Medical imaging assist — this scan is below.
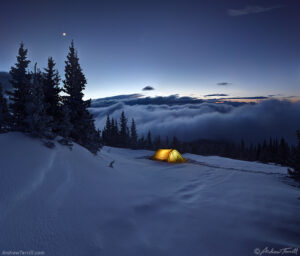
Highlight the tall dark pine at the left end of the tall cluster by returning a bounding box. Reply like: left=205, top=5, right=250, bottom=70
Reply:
left=8, top=43, right=30, bottom=131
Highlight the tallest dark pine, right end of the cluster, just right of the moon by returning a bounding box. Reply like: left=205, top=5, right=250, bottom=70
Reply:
left=63, top=41, right=101, bottom=153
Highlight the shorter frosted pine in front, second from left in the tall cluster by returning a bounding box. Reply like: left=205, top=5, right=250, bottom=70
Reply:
left=24, top=64, right=50, bottom=137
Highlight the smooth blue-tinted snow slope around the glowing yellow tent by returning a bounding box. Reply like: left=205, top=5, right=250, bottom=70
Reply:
left=0, top=133, right=300, bottom=256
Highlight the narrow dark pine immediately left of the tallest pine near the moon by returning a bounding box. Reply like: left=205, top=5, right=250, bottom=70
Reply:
left=43, top=57, right=64, bottom=133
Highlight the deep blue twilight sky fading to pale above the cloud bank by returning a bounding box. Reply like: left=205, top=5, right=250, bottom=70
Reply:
left=0, top=0, right=300, bottom=98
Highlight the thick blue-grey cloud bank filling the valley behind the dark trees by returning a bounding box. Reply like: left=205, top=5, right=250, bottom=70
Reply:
left=90, top=98, right=300, bottom=143
